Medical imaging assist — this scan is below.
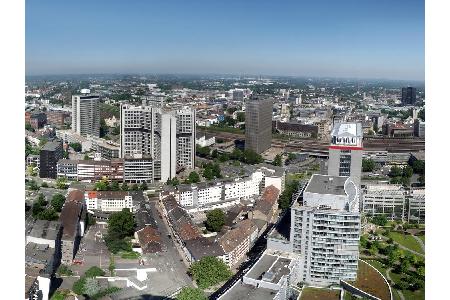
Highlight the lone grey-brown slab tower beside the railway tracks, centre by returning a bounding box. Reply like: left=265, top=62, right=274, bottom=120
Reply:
left=245, top=95, right=273, bottom=154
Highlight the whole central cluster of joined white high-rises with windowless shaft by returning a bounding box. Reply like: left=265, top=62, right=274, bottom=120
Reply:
left=120, top=105, right=195, bottom=181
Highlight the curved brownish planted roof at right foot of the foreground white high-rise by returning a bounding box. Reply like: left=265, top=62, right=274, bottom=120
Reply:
left=348, top=261, right=391, bottom=300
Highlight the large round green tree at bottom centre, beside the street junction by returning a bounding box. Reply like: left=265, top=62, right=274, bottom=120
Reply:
left=189, top=256, right=232, bottom=289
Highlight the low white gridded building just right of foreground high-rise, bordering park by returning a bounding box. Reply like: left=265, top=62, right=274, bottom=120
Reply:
left=362, top=184, right=406, bottom=221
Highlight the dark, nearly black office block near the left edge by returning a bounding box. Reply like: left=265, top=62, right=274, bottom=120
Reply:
left=39, top=140, right=63, bottom=178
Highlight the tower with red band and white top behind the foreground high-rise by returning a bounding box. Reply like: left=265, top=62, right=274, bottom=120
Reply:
left=328, top=123, right=363, bottom=189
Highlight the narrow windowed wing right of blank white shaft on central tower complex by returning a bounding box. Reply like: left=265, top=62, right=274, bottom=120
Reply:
left=176, top=107, right=195, bottom=169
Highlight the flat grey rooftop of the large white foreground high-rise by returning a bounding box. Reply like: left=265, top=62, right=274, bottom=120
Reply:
left=305, top=174, right=348, bottom=196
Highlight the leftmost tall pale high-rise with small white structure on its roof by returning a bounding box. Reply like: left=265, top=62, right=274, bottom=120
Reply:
left=72, top=89, right=100, bottom=137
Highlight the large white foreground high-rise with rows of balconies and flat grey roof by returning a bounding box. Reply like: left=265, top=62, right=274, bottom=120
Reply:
left=290, top=174, right=361, bottom=286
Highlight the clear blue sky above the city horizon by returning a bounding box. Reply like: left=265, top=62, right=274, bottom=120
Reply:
left=25, top=0, right=425, bottom=80
